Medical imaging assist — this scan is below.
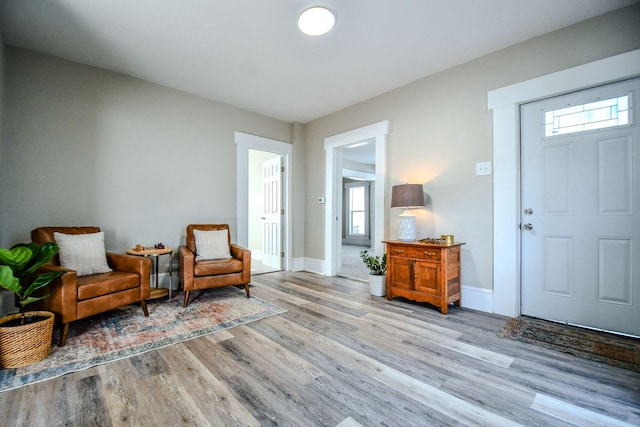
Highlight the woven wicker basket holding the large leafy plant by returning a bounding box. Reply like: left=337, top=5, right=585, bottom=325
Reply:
left=0, top=311, right=55, bottom=368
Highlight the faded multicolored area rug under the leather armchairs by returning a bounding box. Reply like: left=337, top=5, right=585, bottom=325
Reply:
left=0, top=286, right=286, bottom=392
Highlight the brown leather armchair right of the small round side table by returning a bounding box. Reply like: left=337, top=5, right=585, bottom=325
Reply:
left=179, top=224, right=251, bottom=307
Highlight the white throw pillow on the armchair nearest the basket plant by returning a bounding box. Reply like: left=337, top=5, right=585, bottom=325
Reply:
left=53, top=231, right=112, bottom=276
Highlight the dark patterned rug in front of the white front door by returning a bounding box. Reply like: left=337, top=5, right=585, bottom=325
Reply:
left=498, top=317, right=640, bottom=372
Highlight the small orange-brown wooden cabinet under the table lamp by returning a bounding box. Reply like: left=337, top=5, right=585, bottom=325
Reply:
left=383, top=240, right=464, bottom=314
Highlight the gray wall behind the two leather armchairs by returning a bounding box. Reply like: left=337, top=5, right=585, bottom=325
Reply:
left=0, top=46, right=292, bottom=252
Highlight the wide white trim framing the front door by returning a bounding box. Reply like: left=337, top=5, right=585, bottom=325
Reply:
left=488, top=49, right=640, bottom=317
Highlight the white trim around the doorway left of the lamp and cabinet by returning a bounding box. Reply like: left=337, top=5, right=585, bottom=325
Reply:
left=324, top=120, right=389, bottom=276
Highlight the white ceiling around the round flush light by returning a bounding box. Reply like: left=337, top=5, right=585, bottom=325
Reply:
left=0, top=0, right=637, bottom=123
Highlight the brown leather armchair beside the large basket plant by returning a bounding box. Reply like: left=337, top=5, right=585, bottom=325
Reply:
left=31, top=227, right=151, bottom=346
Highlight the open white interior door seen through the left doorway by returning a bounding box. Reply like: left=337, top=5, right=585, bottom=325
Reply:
left=262, top=156, right=282, bottom=269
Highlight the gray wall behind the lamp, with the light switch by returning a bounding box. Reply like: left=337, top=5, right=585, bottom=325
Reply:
left=305, top=5, right=640, bottom=289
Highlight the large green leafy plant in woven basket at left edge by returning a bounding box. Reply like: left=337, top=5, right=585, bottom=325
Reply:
left=0, top=243, right=64, bottom=368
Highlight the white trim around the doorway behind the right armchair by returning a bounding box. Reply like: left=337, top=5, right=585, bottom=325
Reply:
left=234, top=131, right=293, bottom=270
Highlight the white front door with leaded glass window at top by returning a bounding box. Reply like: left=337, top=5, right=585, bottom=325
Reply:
left=521, top=79, right=640, bottom=336
